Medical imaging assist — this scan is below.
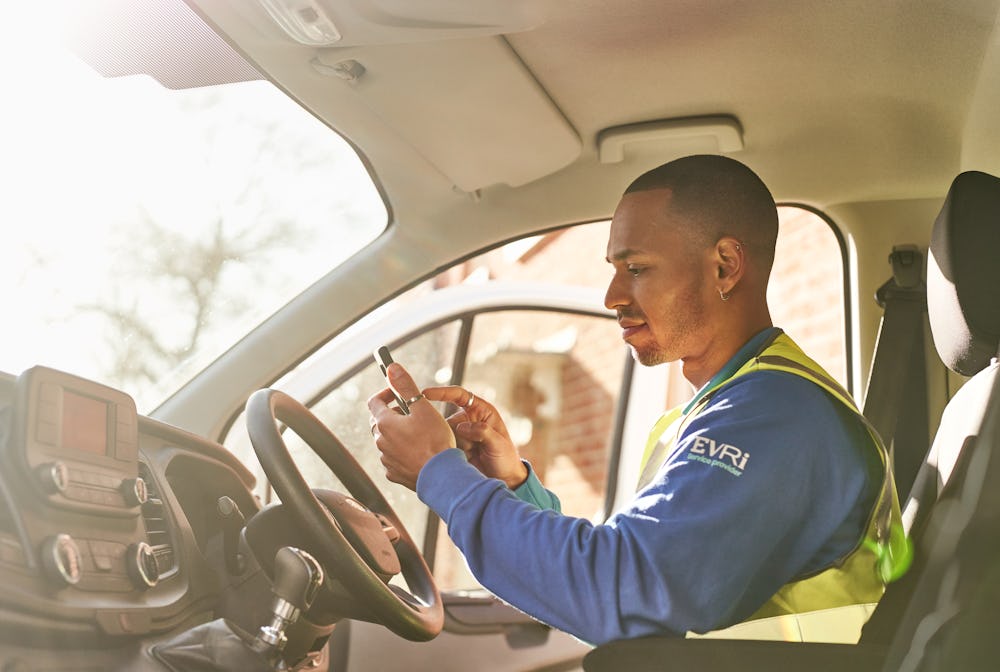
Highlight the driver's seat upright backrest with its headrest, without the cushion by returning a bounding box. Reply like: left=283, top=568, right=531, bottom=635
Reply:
left=862, top=171, right=1000, bottom=670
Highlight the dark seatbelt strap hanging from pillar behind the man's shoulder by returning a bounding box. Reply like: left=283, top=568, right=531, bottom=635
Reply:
left=863, top=245, right=930, bottom=501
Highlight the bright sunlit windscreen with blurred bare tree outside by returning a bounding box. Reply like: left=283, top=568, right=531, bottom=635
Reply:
left=0, top=2, right=387, bottom=412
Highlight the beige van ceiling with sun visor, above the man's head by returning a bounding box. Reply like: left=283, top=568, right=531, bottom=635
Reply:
left=66, top=0, right=1000, bottom=217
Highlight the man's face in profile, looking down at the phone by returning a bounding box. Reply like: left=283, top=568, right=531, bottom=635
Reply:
left=604, top=189, right=718, bottom=366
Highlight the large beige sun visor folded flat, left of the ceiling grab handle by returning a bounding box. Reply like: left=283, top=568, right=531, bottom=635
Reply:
left=314, top=37, right=581, bottom=192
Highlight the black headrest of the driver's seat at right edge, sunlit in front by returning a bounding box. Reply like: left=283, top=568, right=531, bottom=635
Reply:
left=927, top=171, right=1000, bottom=376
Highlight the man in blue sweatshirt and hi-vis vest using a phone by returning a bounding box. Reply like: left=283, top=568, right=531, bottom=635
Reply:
left=369, top=155, right=905, bottom=644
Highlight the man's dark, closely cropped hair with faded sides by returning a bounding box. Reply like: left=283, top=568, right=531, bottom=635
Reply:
left=625, top=154, right=778, bottom=274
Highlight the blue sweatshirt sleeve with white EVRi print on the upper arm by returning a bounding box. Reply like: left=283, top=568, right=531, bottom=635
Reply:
left=417, top=372, right=878, bottom=644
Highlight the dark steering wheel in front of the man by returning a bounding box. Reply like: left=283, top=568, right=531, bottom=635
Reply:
left=247, top=389, right=444, bottom=641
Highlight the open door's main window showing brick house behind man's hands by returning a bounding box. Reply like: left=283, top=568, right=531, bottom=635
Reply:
left=434, top=310, right=627, bottom=590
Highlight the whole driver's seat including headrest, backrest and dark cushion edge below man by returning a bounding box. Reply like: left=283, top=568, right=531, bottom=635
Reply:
left=583, top=171, right=1000, bottom=672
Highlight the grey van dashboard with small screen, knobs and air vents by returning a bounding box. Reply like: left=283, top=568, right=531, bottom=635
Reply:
left=0, top=367, right=270, bottom=670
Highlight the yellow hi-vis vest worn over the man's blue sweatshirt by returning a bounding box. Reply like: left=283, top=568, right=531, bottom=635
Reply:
left=639, top=332, right=912, bottom=643
